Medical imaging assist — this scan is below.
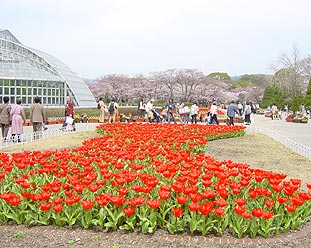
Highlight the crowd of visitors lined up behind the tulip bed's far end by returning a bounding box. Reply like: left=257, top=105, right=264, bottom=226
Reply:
left=98, top=98, right=256, bottom=125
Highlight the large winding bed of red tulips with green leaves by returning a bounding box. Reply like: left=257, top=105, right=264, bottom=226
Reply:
left=0, top=123, right=311, bottom=238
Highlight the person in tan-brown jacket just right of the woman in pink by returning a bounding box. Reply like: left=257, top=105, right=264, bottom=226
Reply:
left=30, top=96, right=47, bottom=139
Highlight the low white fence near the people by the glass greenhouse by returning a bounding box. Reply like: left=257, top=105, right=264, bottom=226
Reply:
left=0, top=123, right=99, bottom=149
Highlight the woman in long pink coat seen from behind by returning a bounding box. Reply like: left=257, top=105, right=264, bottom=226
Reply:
left=10, top=99, right=26, bottom=142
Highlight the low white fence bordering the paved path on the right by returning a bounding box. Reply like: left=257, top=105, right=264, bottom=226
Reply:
left=246, top=126, right=311, bottom=160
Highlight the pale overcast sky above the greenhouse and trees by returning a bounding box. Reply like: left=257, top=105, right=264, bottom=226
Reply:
left=0, top=0, right=311, bottom=79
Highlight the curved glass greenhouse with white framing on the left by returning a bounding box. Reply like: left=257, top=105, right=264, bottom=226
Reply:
left=0, top=29, right=96, bottom=107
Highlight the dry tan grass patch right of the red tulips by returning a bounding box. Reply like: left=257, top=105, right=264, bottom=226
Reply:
left=206, top=133, right=311, bottom=189
